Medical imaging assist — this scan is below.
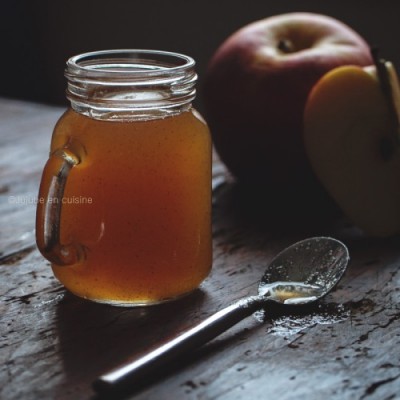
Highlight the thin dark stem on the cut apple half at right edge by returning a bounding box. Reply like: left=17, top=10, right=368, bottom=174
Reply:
left=371, top=48, right=400, bottom=146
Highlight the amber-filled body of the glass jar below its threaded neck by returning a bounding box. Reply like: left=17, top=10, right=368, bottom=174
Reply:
left=37, top=50, right=212, bottom=306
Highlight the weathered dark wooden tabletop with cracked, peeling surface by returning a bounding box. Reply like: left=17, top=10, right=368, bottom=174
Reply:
left=0, top=99, right=400, bottom=400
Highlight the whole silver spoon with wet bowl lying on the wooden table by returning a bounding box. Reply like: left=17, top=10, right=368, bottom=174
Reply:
left=93, top=237, right=349, bottom=393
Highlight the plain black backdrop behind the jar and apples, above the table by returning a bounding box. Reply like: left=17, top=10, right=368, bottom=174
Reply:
left=0, top=0, right=400, bottom=109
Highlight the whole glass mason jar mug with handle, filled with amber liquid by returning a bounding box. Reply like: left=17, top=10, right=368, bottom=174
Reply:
left=36, top=50, right=212, bottom=306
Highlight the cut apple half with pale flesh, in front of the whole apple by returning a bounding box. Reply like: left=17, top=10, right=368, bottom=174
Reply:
left=304, top=62, right=400, bottom=237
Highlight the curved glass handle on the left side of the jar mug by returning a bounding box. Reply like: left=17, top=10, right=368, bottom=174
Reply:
left=36, top=148, right=85, bottom=265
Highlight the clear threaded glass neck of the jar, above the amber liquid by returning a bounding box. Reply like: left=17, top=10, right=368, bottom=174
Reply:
left=65, top=49, right=197, bottom=119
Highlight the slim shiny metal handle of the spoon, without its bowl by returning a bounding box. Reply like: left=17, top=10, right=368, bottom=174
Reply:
left=93, top=296, right=265, bottom=393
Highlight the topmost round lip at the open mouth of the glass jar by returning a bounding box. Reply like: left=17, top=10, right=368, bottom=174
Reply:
left=66, top=49, right=195, bottom=78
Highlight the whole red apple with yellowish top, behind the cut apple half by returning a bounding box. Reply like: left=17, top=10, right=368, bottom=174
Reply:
left=203, top=13, right=372, bottom=208
